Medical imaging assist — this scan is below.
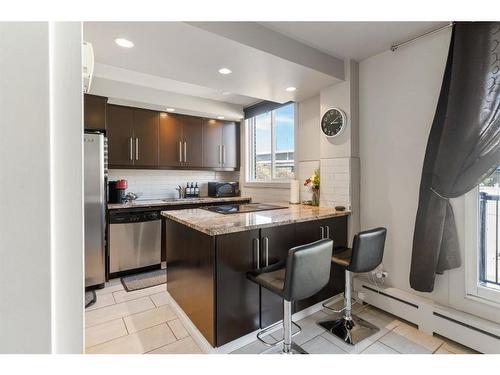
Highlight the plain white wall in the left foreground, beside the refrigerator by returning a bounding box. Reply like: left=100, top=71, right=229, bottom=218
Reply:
left=0, top=22, right=83, bottom=353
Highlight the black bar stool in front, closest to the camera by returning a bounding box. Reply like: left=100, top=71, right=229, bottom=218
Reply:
left=247, top=240, right=333, bottom=354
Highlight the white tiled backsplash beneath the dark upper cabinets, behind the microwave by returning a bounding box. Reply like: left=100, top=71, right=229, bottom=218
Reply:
left=108, top=169, right=240, bottom=199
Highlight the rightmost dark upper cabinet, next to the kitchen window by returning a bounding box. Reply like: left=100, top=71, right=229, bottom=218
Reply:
left=203, top=120, right=239, bottom=169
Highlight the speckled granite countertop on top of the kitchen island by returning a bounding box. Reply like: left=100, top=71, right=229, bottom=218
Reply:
left=161, top=203, right=351, bottom=236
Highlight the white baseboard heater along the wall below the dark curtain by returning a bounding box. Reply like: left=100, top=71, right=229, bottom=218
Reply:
left=354, top=278, right=500, bottom=354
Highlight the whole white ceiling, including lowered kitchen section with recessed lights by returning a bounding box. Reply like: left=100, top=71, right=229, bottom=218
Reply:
left=83, top=22, right=446, bottom=110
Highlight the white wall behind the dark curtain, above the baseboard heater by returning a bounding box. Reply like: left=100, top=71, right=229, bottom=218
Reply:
left=359, top=30, right=500, bottom=321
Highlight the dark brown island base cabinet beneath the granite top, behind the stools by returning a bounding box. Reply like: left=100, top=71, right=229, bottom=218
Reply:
left=165, top=217, right=347, bottom=347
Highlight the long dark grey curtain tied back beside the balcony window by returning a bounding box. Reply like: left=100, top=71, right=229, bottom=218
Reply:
left=410, top=22, right=500, bottom=292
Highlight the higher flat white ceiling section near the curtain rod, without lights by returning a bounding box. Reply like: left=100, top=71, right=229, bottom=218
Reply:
left=260, top=22, right=449, bottom=61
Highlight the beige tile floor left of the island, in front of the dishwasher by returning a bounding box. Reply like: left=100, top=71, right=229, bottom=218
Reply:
left=85, top=279, right=202, bottom=354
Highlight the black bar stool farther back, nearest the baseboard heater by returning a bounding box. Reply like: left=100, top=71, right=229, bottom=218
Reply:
left=318, top=228, right=387, bottom=345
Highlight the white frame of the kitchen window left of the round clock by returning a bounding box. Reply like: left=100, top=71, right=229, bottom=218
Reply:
left=244, top=103, right=297, bottom=188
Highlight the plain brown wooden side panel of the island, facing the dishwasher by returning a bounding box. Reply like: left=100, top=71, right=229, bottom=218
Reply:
left=165, top=219, right=216, bottom=346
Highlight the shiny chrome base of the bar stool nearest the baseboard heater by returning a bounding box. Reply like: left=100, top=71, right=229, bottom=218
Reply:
left=318, top=315, right=380, bottom=345
